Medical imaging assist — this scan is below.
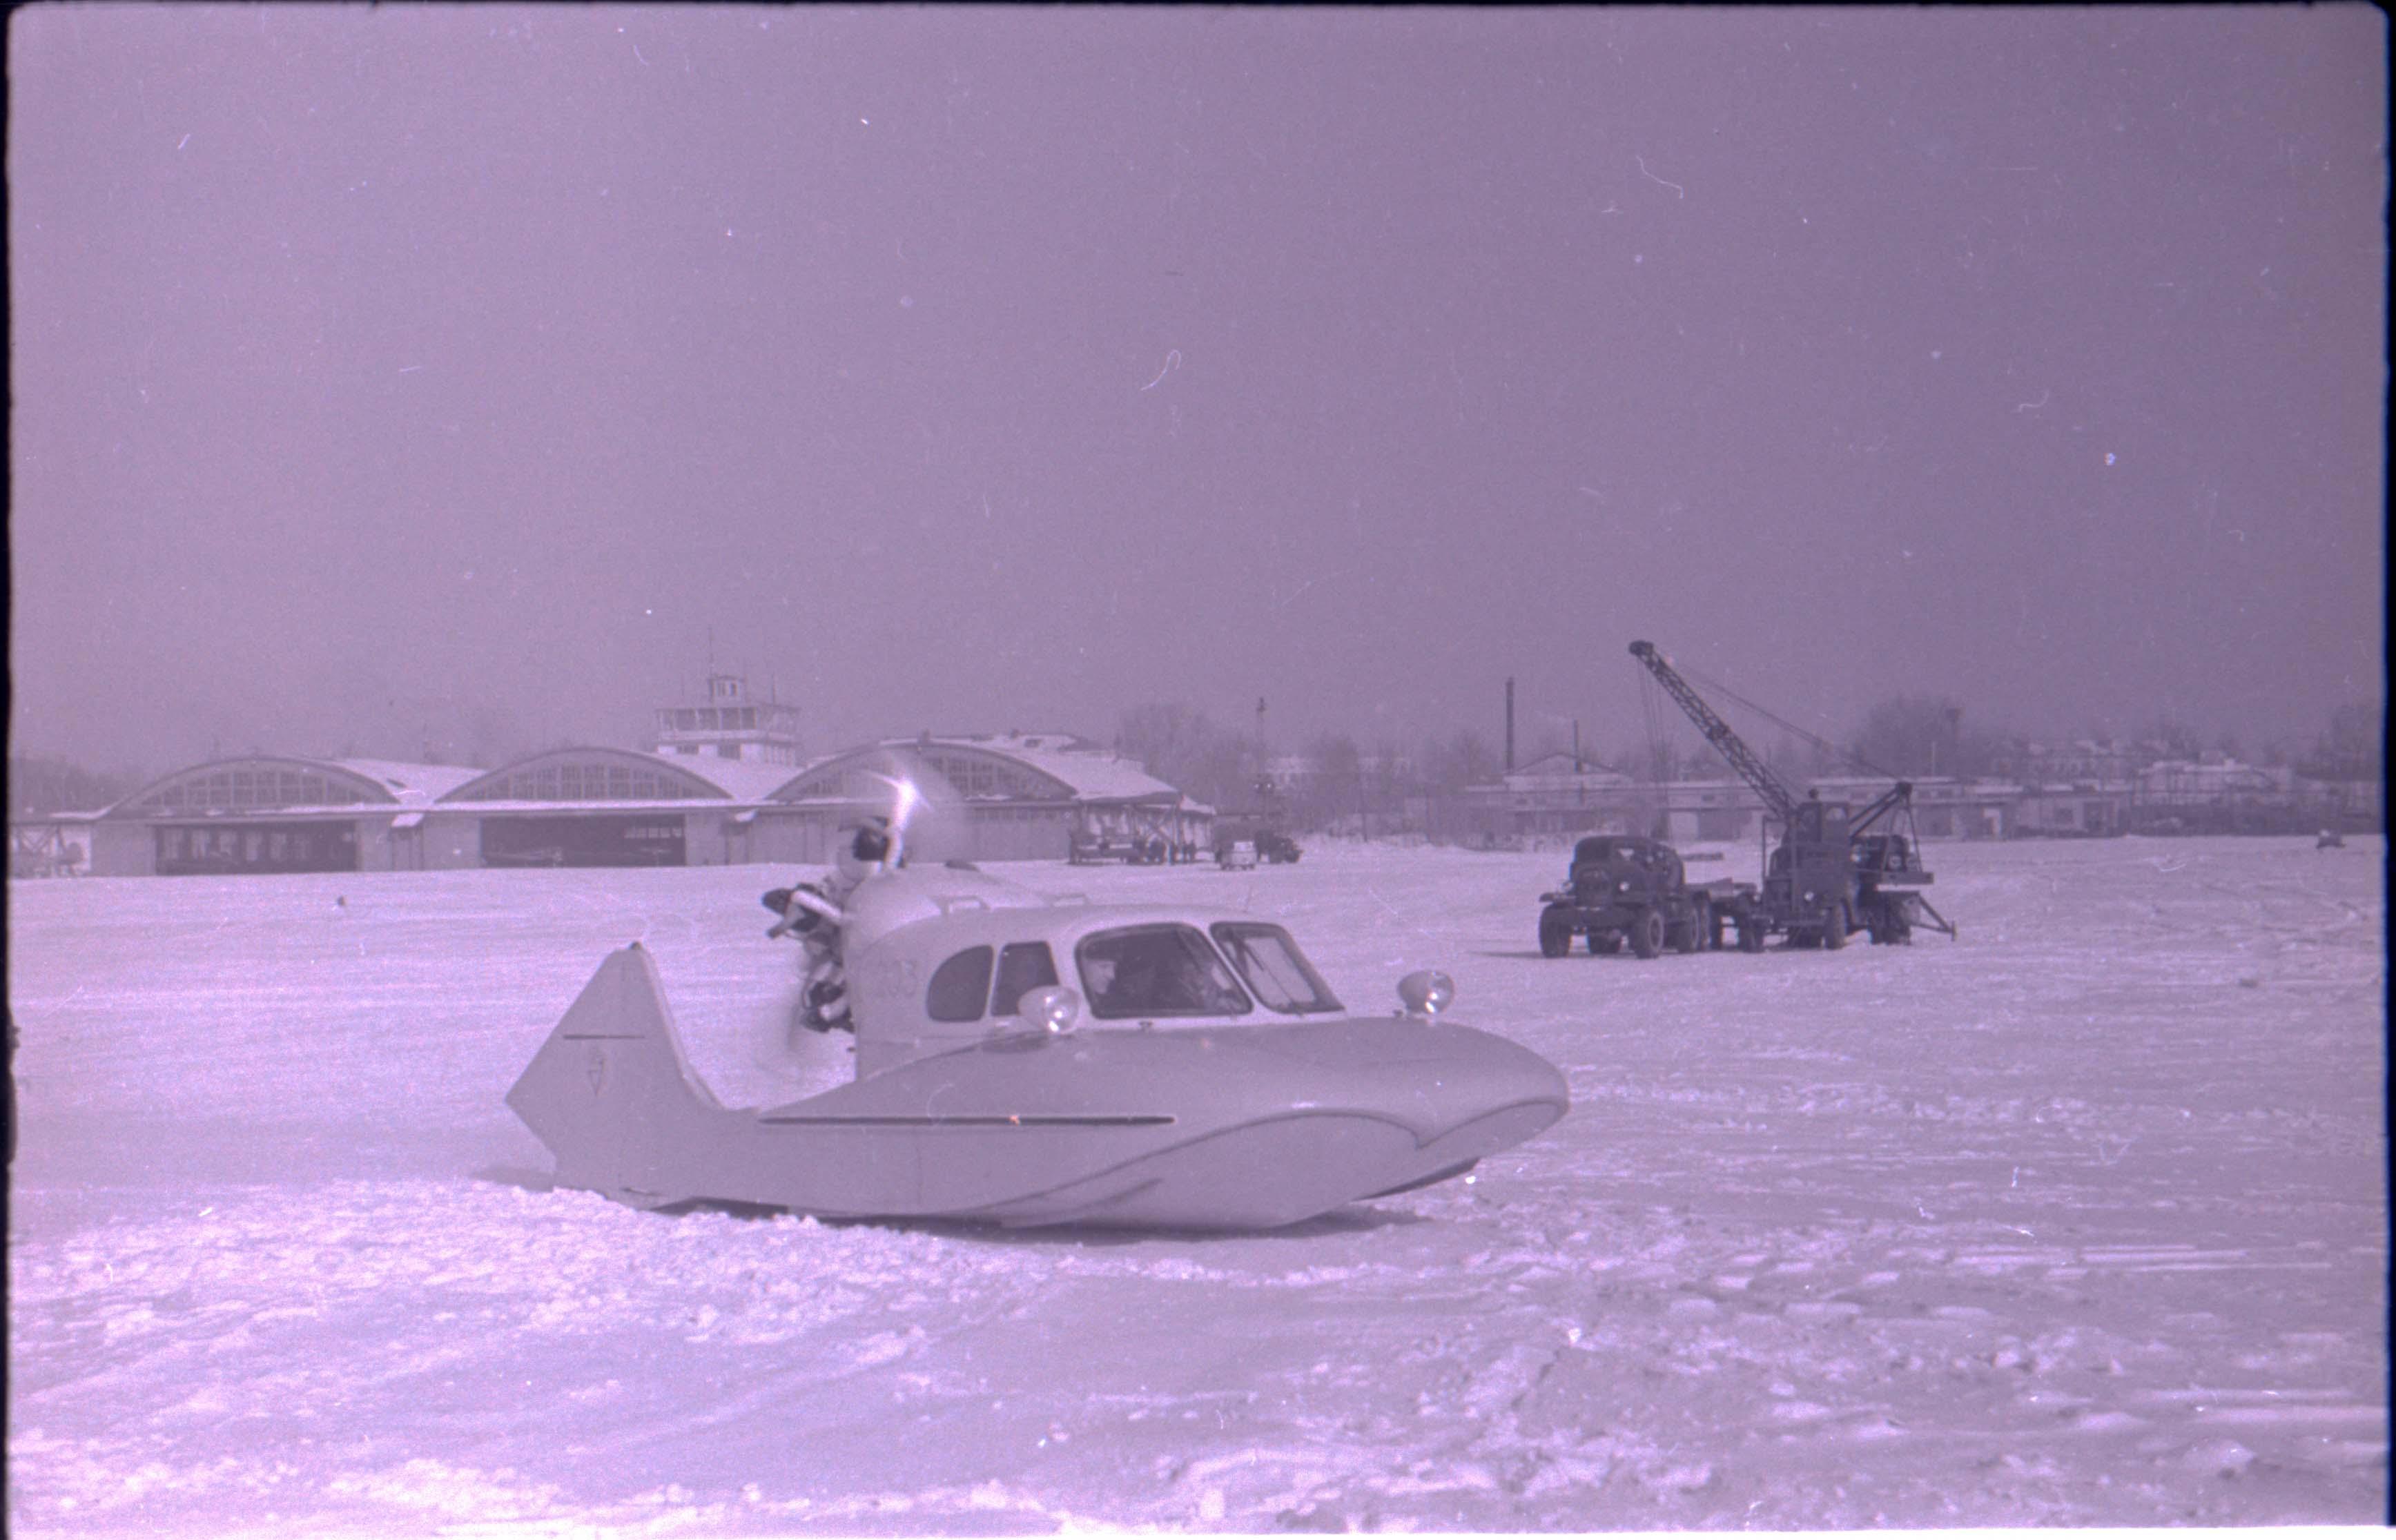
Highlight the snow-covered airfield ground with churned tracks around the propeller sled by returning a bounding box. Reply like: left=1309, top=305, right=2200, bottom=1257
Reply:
left=7, top=841, right=2389, bottom=1535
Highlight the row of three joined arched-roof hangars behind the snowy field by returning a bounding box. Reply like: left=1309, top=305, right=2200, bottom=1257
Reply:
left=91, top=733, right=1212, bottom=877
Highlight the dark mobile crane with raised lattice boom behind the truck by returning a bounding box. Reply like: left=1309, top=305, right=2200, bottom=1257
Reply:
left=1632, top=642, right=1955, bottom=948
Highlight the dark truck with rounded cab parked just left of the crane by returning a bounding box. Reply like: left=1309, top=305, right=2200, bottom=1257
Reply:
left=1538, top=833, right=1764, bottom=958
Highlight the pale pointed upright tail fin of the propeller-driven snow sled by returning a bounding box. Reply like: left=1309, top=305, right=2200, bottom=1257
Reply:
left=508, top=942, right=723, bottom=1207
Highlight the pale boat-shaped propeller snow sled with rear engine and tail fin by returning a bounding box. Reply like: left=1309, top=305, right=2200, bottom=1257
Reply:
left=508, top=821, right=1570, bottom=1229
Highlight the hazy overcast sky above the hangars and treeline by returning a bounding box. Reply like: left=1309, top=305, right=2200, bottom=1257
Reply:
left=7, top=7, right=2389, bottom=771
